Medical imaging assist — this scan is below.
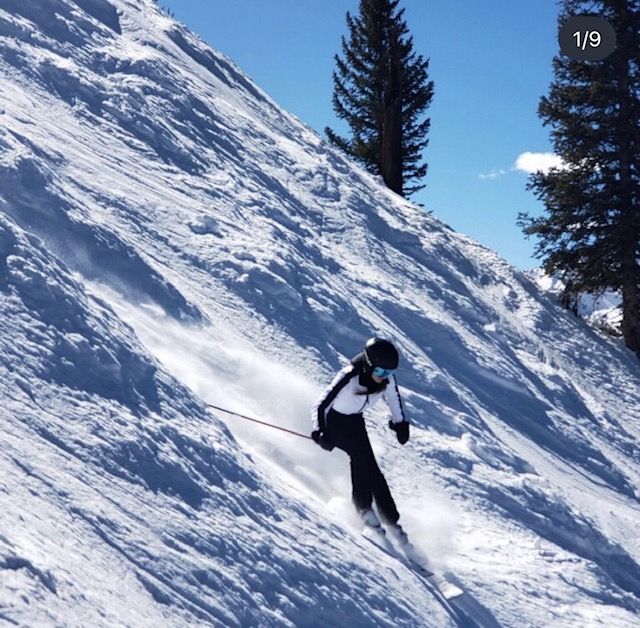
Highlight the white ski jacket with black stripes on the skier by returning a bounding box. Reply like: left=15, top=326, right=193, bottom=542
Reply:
left=311, top=364, right=406, bottom=431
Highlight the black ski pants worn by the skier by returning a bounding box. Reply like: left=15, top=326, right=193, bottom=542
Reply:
left=327, top=410, right=400, bottom=523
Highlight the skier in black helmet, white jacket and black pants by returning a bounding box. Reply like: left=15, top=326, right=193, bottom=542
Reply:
left=311, top=338, right=409, bottom=541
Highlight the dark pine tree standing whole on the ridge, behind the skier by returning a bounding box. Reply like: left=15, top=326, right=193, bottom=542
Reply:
left=325, top=0, right=433, bottom=196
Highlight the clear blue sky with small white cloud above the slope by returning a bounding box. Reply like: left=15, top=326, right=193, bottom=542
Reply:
left=160, top=0, right=559, bottom=269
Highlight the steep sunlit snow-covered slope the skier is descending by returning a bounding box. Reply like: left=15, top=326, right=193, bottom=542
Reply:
left=0, top=0, right=640, bottom=627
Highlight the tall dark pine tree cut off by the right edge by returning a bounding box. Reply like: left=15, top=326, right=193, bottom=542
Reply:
left=519, top=0, right=640, bottom=357
